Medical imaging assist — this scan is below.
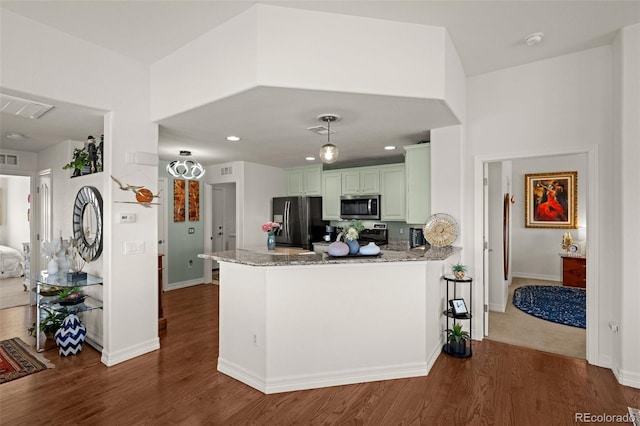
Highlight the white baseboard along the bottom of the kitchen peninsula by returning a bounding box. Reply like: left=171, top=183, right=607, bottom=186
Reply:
left=218, top=357, right=430, bottom=394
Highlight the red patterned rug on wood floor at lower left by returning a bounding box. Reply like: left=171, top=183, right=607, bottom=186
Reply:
left=0, top=337, right=53, bottom=383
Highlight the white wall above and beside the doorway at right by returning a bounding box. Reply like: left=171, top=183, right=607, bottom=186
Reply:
left=468, top=46, right=616, bottom=365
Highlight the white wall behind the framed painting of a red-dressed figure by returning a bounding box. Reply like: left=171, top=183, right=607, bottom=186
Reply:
left=512, top=154, right=589, bottom=281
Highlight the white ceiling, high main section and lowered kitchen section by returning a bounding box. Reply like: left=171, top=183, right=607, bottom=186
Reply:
left=0, top=0, right=640, bottom=166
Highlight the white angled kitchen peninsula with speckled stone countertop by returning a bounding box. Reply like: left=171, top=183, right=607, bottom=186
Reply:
left=198, top=247, right=460, bottom=393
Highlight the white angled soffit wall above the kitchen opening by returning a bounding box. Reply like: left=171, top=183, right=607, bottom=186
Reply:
left=151, top=4, right=464, bottom=121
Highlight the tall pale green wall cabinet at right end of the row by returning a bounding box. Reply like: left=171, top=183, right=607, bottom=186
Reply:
left=404, top=144, right=431, bottom=224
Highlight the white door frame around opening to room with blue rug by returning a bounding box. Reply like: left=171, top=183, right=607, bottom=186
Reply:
left=473, top=145, right=606, bottom=366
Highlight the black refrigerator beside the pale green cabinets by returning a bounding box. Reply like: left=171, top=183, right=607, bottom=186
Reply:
left=271, top=197, right=329, bottom=250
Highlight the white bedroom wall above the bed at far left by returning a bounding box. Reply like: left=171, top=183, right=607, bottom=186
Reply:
left=0, top=175, right=31, bottom=253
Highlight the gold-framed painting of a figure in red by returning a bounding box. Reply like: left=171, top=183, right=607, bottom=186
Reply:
left=524, top=171, right=578, bottom=229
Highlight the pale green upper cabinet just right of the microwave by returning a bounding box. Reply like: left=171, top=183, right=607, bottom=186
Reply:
left=380, top=164, right=406, bottom=220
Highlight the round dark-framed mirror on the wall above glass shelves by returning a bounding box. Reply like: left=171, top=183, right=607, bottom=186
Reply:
left=73, top=186, right=102, bottom=262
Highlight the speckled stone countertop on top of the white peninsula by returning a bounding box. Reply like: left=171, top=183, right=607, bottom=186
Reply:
left=198, top=246, right=462, bottom=266
